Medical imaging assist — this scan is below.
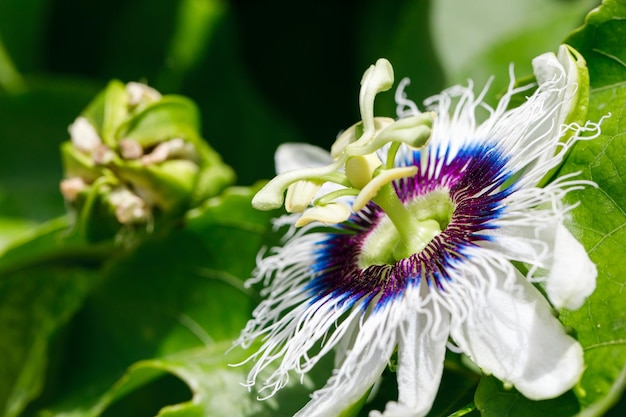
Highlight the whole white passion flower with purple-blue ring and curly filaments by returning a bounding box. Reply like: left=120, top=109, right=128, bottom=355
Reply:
left=237, top=47, right=599, bottom=416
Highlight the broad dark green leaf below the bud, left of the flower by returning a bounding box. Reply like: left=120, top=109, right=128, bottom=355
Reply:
left=36, top=187, right=300, bottom=416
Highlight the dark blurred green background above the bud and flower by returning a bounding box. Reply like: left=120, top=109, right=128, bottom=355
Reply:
left=0, top=0, right=596, bottom=221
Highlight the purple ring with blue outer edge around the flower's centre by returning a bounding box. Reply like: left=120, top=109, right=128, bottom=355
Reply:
left=309, top=142, right=514, bottom=306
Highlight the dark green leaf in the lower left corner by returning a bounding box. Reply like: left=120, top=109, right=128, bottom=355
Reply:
left=0, top=263, right=95, bottom=417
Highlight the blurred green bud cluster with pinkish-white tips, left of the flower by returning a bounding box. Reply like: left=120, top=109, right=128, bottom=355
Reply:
left=60, top=81, right=234, bottom=241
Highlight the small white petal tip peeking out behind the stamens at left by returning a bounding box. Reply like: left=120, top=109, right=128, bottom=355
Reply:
left=274, top=143, right=333, bottom=174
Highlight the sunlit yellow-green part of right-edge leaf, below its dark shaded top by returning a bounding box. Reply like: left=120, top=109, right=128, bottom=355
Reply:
left=562, top=77, right=626, bottom=407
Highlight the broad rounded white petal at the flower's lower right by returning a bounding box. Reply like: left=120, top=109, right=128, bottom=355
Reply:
left=451, top=268, right=583, bottom=400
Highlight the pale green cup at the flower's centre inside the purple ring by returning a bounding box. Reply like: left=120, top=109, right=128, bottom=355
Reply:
left=359, top=190, right=455, bottom=268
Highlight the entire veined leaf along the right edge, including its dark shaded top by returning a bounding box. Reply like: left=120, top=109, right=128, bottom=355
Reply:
left=561, top=0, right=626, bottom=416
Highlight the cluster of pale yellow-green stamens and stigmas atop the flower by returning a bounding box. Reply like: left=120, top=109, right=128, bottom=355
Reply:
left=252, top=59, right=435, bottom=234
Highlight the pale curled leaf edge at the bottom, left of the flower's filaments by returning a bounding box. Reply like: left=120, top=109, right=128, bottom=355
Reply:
left=42, top=341, right=326, bottom=417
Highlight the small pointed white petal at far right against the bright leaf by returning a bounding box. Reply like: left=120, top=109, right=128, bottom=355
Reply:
left=546, top=224, right=598, bottom=310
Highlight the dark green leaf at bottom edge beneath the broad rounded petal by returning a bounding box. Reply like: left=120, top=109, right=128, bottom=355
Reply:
left=474, top=376, right=580, bottom=417
